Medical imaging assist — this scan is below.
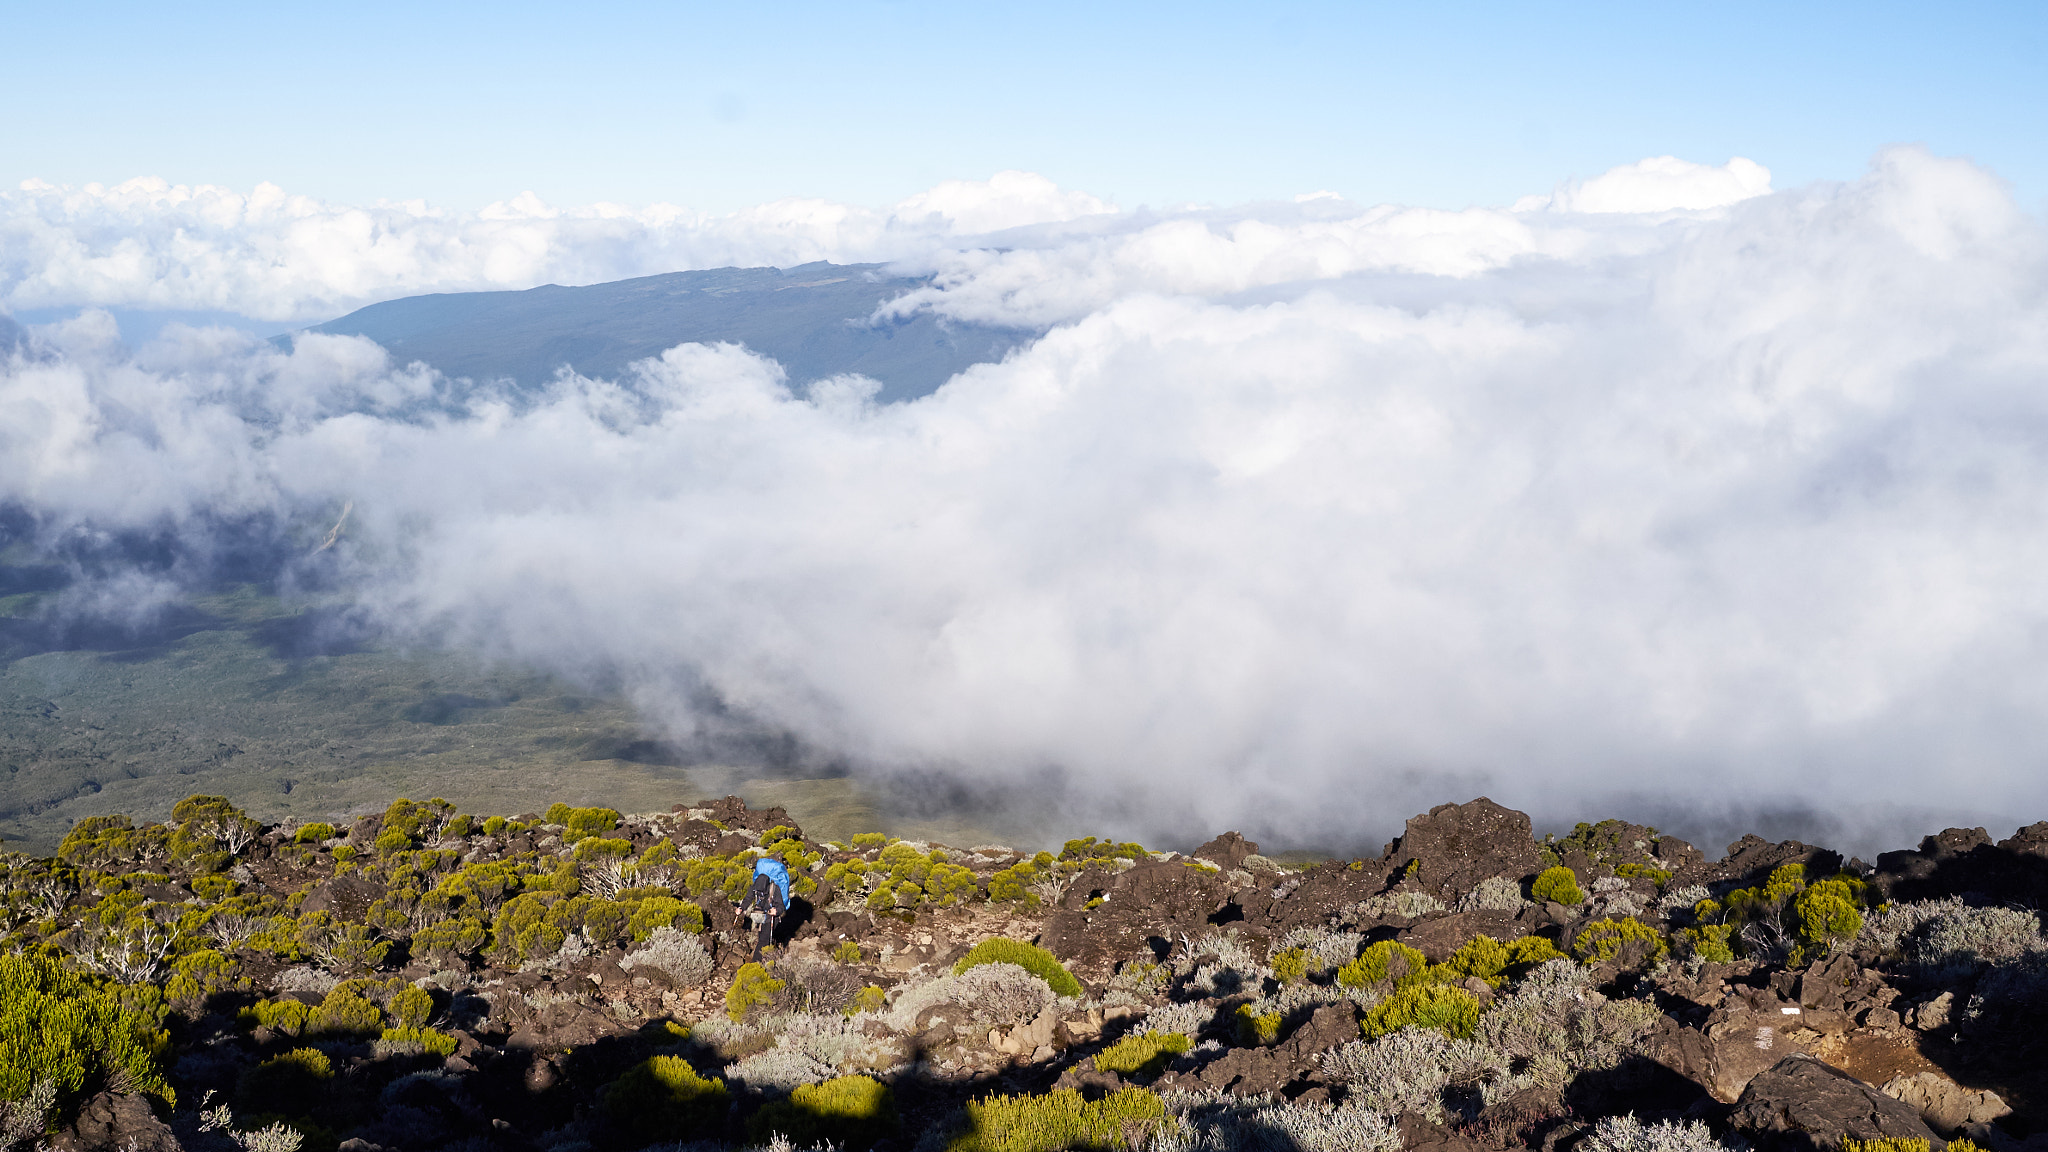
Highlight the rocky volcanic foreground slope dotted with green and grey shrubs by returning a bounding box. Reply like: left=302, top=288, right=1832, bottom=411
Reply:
left=0, top=797, right=2048, bottom=1152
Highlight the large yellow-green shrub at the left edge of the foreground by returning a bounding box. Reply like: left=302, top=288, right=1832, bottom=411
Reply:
left=0, top=955, right=174, bottom=1109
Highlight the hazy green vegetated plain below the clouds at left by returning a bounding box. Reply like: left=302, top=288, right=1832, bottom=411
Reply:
left=0, top=568, right=995, bottom=855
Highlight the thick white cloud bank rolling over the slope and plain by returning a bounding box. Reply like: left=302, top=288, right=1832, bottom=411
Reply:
left=0, top=150, right=2048, bottom=838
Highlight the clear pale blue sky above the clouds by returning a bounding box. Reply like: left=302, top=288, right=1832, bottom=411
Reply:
left=0, top=0, right=2048, bottom=211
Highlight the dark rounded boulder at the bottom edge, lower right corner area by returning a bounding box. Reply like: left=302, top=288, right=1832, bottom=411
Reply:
left=1729, top=1054, right=1939, bottom=1152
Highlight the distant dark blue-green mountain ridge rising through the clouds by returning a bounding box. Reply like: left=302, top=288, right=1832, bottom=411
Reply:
left=296, top=262, right=1036, bottom=402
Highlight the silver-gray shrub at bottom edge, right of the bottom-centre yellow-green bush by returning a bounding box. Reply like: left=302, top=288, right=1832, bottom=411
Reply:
left=1147, top=1093, right=1401, bottom=1152
